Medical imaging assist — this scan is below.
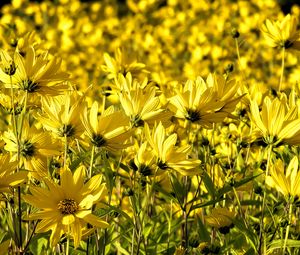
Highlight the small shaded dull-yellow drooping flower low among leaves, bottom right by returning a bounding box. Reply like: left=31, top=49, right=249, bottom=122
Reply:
left=205, top=207, right=235, bottom=234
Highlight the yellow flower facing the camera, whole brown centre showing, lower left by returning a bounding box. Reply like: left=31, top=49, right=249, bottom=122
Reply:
left=24, top=167, right=109, bottom=247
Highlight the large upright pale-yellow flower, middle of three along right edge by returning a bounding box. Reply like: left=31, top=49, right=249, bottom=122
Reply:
left=250, top=94, right=300, bottom=145
